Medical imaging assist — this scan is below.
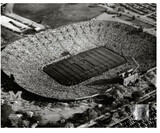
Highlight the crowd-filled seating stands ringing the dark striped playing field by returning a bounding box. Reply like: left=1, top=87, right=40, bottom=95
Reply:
left=1, top=20, right=156, bottom=99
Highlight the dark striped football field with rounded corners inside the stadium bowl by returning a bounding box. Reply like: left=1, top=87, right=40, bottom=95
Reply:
left=43, top=47, right=126, bottom=86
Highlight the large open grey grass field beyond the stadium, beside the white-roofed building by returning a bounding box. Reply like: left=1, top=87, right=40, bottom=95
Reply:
left=13, top=3, right=104, bottom=28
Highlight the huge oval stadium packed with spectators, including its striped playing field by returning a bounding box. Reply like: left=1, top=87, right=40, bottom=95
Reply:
left=1, top=20, right=156, bottom=99
